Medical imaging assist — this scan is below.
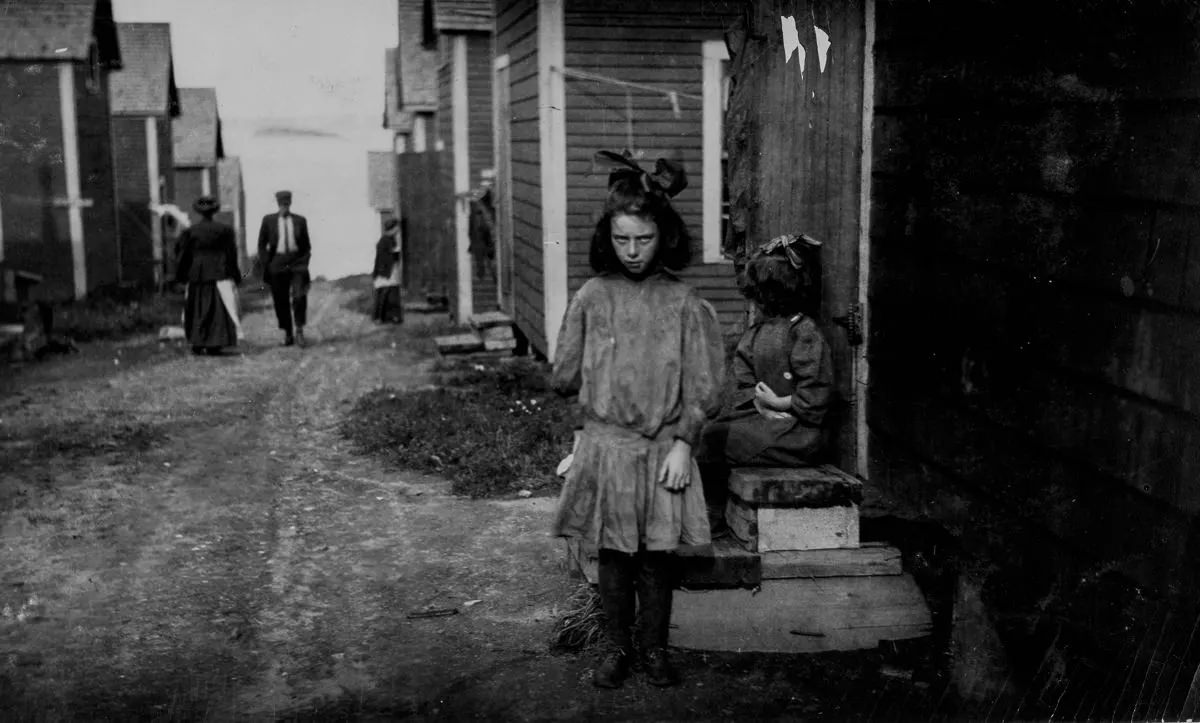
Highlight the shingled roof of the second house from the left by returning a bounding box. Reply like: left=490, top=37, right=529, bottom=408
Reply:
left=109, top=23, right=179, bottom=115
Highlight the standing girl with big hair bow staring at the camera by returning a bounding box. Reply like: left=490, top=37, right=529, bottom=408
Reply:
left=553, top=151, right=724, bottom=688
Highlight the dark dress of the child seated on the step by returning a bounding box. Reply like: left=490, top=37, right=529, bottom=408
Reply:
left=702, top=313, right=833, bottom=467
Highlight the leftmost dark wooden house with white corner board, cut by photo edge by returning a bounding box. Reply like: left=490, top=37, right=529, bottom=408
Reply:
left=0, top=0, right=121, bottom=305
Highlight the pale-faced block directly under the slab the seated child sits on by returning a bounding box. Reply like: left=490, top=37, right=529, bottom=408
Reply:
left=725, top=495, right=858, bottom=552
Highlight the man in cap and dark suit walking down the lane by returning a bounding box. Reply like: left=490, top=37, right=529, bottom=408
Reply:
left=258, top=191, right=312, bottom=346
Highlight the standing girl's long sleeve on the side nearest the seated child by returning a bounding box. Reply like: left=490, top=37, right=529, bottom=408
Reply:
left=676, top=297, right=725, bottom=448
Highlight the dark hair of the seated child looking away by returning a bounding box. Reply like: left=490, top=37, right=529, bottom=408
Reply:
left=739, top=246, right=821, bottom=317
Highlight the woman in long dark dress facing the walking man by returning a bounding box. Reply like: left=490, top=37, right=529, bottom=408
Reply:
left=175, top=196, right=241, bottom=354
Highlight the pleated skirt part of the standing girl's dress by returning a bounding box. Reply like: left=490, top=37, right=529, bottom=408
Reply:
left=553, top=422, right=712, bottom=552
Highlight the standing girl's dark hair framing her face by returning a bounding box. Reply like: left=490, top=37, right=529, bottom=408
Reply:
left=588, top=178, right=691, bottom=274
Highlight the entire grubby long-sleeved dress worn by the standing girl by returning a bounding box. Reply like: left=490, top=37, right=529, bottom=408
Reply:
left=553, top=271, right=724, bottom=552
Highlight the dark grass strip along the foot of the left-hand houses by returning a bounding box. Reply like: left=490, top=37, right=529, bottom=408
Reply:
left=54, top=284, right=184, bottom=341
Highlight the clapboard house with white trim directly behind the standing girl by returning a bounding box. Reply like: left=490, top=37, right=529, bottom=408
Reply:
left=494, top=0, right=745, bottom=357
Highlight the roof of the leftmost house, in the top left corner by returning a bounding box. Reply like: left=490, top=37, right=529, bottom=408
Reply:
left=0, top=0, right=121, bottom=62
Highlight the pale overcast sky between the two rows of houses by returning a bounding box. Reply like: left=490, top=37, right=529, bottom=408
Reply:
left=113, top=0, right=397, bottom=277
